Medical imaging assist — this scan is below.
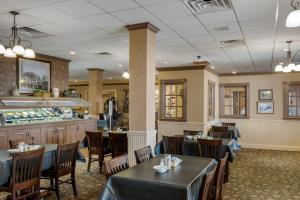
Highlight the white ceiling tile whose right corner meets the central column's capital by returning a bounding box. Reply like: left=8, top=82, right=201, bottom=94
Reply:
left=81, top=14, right=125, bottom=28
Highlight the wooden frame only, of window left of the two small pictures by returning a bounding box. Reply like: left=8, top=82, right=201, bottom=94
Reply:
left=219, top=82, right=250, bottom=119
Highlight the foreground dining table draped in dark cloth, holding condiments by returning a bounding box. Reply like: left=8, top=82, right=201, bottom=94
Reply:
left=99, top=154, right=217, bottom=200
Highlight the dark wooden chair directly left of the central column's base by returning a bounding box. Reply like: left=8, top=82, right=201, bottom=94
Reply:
left=109, top=133, right=128, bottom=158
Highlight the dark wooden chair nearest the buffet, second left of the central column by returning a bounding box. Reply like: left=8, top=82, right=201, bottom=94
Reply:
left=85, top=131, right=105, bottom=172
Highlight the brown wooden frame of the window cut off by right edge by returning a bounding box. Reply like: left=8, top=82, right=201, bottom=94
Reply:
left=283, top=81, right=300, bottom=120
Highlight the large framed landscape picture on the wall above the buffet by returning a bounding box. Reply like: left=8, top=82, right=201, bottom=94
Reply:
left=17, top=58, right=51, bottom=94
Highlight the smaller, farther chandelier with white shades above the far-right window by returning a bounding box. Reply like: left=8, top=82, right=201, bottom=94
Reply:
left=275, top=41, right=300, bottom=73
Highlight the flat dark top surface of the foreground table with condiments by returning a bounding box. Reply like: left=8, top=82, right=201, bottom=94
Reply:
left=112, top=155, right=214, bottom=188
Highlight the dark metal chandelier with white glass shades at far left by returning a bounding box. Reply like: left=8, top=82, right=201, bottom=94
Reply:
left=0, top=11, right=35, bottom=58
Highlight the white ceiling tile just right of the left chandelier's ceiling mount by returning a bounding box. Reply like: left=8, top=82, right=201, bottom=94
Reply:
left=23, top=6, right=72, bottom=22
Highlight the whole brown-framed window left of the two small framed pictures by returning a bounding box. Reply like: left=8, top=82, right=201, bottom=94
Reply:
left=220, top=83, right=250, bottom=118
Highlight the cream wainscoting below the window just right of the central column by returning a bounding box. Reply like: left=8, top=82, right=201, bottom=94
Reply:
left=158, top=121, right=204, bottom=141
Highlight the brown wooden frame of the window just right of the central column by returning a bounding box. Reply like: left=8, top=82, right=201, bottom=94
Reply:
left=159, top=79, right=187, bottom=121
